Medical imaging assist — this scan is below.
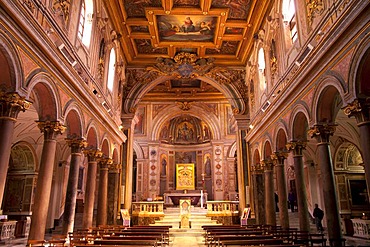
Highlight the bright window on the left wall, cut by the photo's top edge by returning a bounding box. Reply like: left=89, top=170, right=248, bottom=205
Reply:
left=78, top=0, right=94, bottom=47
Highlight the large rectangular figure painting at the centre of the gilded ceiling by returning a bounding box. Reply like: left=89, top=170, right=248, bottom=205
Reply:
left=157, top=15, right=217, bottom=42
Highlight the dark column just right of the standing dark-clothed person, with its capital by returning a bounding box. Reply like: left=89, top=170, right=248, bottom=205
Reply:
left=308, top=124, right=342, bottom=246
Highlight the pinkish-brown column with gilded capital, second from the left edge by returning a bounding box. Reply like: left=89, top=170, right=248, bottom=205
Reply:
left=28, top=121, right=66, bottom=240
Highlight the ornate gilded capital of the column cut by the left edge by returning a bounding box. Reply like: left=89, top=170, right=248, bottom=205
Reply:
left=0, top=91, right=32, bottom=120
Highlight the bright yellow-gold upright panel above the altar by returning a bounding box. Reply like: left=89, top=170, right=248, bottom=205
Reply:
left=176, top=163, right=195, bottom=190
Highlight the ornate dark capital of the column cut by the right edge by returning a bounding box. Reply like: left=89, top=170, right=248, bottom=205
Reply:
left=342, top=98, right=370, bottom=124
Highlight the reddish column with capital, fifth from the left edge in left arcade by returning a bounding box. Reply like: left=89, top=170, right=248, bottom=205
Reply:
left=96, top=158, right=113, bottom=226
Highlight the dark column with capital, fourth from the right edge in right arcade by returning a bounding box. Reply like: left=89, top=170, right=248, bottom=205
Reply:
left=271, top=151, right=289, bottom=229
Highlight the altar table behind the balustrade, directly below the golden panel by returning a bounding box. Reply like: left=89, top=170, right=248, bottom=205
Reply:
left=163, top=191, right=207, bottom=206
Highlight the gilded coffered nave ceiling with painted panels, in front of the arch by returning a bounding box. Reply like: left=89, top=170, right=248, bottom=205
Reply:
left=105, top=0, right=274, bottom=67
